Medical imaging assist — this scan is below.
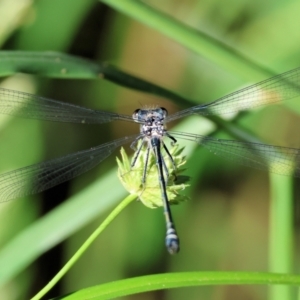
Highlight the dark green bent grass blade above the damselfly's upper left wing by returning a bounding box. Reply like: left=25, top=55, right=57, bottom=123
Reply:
left=0, top=51, right=193, bottom=106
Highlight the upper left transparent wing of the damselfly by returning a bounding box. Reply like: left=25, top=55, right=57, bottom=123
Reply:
left=0, top=88, right=132, bottom=123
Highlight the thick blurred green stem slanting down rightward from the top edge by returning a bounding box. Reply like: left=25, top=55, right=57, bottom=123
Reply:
left=101, top=0, right=274, bottom=81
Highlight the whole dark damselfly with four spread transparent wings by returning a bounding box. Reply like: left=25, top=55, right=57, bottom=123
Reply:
left=0, top=68, right=300, bottom=254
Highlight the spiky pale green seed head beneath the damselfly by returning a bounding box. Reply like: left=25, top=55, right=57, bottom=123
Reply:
left=117, top=144, right=189, bottom=208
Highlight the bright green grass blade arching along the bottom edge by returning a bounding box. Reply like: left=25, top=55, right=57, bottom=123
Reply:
left=53, top=272, right=300, bottom=300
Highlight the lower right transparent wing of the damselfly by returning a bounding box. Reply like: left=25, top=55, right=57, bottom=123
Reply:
left=170, top=132, right=300, bottom=177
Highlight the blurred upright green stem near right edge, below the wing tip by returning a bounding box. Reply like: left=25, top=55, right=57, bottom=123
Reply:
left=269, top=174, right=293, bottom=300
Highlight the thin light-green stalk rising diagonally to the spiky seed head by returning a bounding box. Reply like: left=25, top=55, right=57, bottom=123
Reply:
left=31, top=195, right=136, bottom=300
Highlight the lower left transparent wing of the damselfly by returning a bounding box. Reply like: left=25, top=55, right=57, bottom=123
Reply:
left=0, top=135, right=137, bottom=202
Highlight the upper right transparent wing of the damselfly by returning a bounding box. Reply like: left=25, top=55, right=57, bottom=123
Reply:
left=167, top=68, right=300, bottom=122
